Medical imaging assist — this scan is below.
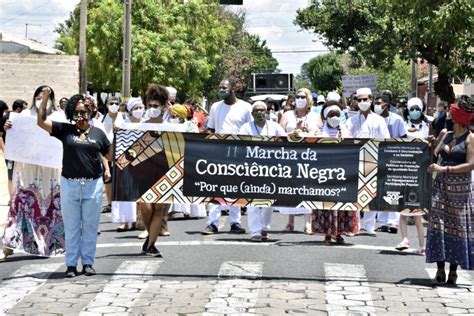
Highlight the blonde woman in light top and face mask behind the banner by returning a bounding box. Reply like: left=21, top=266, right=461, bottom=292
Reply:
left=278, top=88, right=319, bottom=235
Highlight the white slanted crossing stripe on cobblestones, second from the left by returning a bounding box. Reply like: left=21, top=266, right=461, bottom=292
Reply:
left=80, top=259, right=163, bottom=315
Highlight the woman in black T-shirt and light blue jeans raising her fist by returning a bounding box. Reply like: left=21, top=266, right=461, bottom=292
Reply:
left=37, top=87, right=111, bottom=277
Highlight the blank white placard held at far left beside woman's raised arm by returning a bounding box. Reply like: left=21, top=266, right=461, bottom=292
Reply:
left=5, top=112, right=63, bottom=169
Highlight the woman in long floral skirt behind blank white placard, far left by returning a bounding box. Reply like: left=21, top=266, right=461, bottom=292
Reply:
left=0, top=86, right=65, bottom=260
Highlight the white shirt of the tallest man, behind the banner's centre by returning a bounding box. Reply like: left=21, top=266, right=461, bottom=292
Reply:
left=207, top=99, right=253, bottom=134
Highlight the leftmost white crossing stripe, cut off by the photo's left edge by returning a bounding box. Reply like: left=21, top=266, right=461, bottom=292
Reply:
left=0, top=263, right=63, bottom=315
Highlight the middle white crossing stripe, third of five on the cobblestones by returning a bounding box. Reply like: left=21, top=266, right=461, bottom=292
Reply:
left=203, top=261, right=263, bottom=315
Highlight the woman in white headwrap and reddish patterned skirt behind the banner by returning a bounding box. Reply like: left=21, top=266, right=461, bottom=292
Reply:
left=312, top=92, right=357, bottom=246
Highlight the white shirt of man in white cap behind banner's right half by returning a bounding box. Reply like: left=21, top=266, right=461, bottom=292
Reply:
left=346, top=112, right=390, bottom=138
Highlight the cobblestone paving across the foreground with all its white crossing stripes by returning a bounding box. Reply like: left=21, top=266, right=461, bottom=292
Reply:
left=0, top=258, right=474, bottom=315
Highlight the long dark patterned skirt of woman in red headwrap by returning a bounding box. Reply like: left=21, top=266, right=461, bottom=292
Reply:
left=426, top=172, right=474, bottom=270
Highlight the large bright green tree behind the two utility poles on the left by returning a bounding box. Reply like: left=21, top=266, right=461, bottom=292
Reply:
left=56, top=0, right=276, bottom=97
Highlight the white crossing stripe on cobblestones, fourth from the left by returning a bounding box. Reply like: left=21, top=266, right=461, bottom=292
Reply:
left=324, top=263, right=375, bottom=316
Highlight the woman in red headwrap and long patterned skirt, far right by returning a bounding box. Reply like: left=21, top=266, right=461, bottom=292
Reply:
left=426, top=97, right=474, bottom=286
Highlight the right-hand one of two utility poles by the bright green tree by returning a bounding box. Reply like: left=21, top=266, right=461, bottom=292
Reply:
left=122, top=0, right=132, bottom=100
